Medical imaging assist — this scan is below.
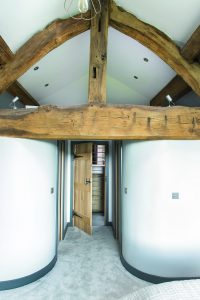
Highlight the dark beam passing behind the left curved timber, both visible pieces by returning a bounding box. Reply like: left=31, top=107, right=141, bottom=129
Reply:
left=0, top=36, right=39, bottom=105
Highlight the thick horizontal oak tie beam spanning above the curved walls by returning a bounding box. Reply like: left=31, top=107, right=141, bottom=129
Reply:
left=0, top=105, right=200, bottom=140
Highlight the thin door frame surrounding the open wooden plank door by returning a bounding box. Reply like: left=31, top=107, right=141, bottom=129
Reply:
left=69, top=140, right=109, bottom=226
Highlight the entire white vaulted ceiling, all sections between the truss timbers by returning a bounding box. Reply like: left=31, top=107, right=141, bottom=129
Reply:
left=0, top=0, right=200, bottom=106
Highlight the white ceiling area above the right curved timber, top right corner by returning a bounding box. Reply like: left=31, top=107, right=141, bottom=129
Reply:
left=115, top=0, right=200, bottom=43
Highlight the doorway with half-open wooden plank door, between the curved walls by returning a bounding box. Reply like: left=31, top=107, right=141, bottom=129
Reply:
left=72, top=142, right=108, bottom=234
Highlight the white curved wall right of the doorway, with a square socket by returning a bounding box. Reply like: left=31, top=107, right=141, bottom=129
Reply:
left=122, top=141, right=200, bottom=277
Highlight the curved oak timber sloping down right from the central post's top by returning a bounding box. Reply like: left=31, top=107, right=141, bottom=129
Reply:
left=110, top=2, right=200, bottom=95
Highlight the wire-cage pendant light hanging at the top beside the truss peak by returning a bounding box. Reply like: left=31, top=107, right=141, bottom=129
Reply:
left=64, top=0, right=101, bottom=20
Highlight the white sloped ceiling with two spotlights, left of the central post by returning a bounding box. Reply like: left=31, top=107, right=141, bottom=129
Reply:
left=19, top=31, right=90, bottom=105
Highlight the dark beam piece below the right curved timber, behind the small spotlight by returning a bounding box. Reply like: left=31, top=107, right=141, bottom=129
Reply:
left=150, top=75, right=192, bottom=106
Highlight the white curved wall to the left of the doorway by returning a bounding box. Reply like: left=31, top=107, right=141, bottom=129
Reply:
left=0, top=138, right=57, bottom=281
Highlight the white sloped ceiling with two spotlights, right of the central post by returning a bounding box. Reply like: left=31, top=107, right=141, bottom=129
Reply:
left=108, top=29, right=176, bottom=104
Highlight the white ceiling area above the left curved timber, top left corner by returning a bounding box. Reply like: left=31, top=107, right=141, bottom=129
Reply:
left=0, top=0, right=77, bottom=52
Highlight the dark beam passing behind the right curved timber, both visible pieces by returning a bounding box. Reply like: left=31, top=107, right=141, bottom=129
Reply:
left=150, top=26, right=200, bottom=106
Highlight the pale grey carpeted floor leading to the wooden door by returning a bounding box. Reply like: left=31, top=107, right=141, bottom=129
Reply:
left=0, top=226, right=149, bottom=300
